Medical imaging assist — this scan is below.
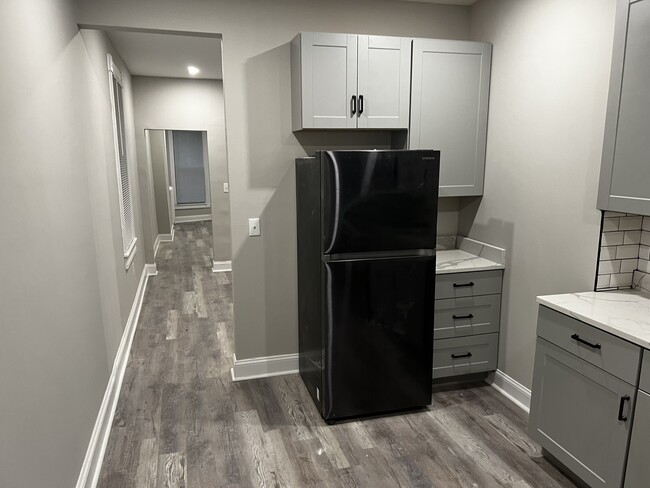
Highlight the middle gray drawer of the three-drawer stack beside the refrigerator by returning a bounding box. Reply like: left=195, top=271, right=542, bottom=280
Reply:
left=433, top=295, right=501, bottom=339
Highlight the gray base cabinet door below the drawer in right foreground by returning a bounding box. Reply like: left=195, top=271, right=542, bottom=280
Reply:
left=529, top=338, right=635, bottom=488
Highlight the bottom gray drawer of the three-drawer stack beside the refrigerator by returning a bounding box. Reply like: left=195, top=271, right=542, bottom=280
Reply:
left=433, top=334, right=499, bottom=379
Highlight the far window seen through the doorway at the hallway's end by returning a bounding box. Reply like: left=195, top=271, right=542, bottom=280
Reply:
left=169, top=130, right=210, bottom=209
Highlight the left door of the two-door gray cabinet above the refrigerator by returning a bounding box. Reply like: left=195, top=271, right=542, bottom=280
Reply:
left=291, top=32, right=357, bottom=130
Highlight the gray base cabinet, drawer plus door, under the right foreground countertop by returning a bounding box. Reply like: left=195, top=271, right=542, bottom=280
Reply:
left=529, top=306, right=641, bottom=487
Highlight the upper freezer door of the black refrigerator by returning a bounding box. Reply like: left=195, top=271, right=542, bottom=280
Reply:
left=320, top=150, right=440, bottom=254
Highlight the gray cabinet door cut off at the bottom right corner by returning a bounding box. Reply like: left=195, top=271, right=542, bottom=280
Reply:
left=625, top=390, right=650, bottom=488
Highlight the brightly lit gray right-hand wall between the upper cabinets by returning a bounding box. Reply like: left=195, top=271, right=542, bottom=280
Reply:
left=459, top=0, right=615, bottom=387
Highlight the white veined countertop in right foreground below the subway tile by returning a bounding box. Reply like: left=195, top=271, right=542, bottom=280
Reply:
left=537, top=290, right=650, bottom=349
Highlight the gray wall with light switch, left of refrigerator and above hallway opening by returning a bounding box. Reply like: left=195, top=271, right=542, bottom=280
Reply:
left=79, top=0, right=469, bottom=359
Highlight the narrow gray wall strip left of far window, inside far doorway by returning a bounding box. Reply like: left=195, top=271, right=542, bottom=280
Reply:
left=145, top=129, right=172, bottom=234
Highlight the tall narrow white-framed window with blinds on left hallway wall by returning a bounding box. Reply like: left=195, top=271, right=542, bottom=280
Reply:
left=108, top=54, right=137, bottom=269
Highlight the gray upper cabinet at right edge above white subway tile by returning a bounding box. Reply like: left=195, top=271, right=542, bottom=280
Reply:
left=596, top=0, right=650, bottom=215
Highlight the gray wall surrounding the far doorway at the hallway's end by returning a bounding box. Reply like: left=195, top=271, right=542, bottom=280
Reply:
left=133, top=77, right=231, bottom=262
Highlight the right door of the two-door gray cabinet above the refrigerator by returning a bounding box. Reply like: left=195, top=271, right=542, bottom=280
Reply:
left=357, top=35, right=411, bottom=129
